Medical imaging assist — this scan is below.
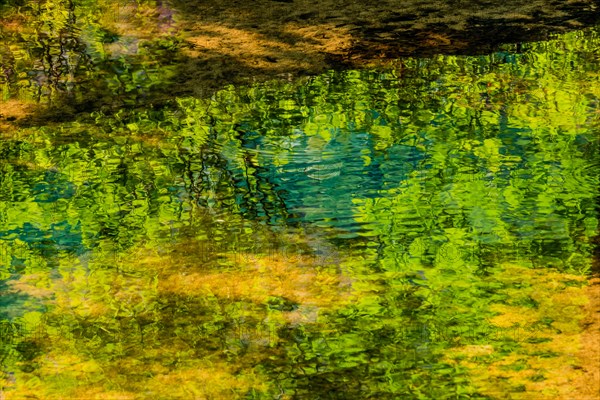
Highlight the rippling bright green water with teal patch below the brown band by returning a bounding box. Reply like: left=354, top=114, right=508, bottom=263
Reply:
left=0, top=0, right=600, bottom=399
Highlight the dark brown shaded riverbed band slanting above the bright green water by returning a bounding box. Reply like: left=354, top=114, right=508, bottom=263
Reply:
left=0, top=0, right=600, bottom=127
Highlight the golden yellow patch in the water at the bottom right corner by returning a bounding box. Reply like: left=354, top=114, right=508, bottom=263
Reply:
left=447, top=265, right=600, bottom=400
